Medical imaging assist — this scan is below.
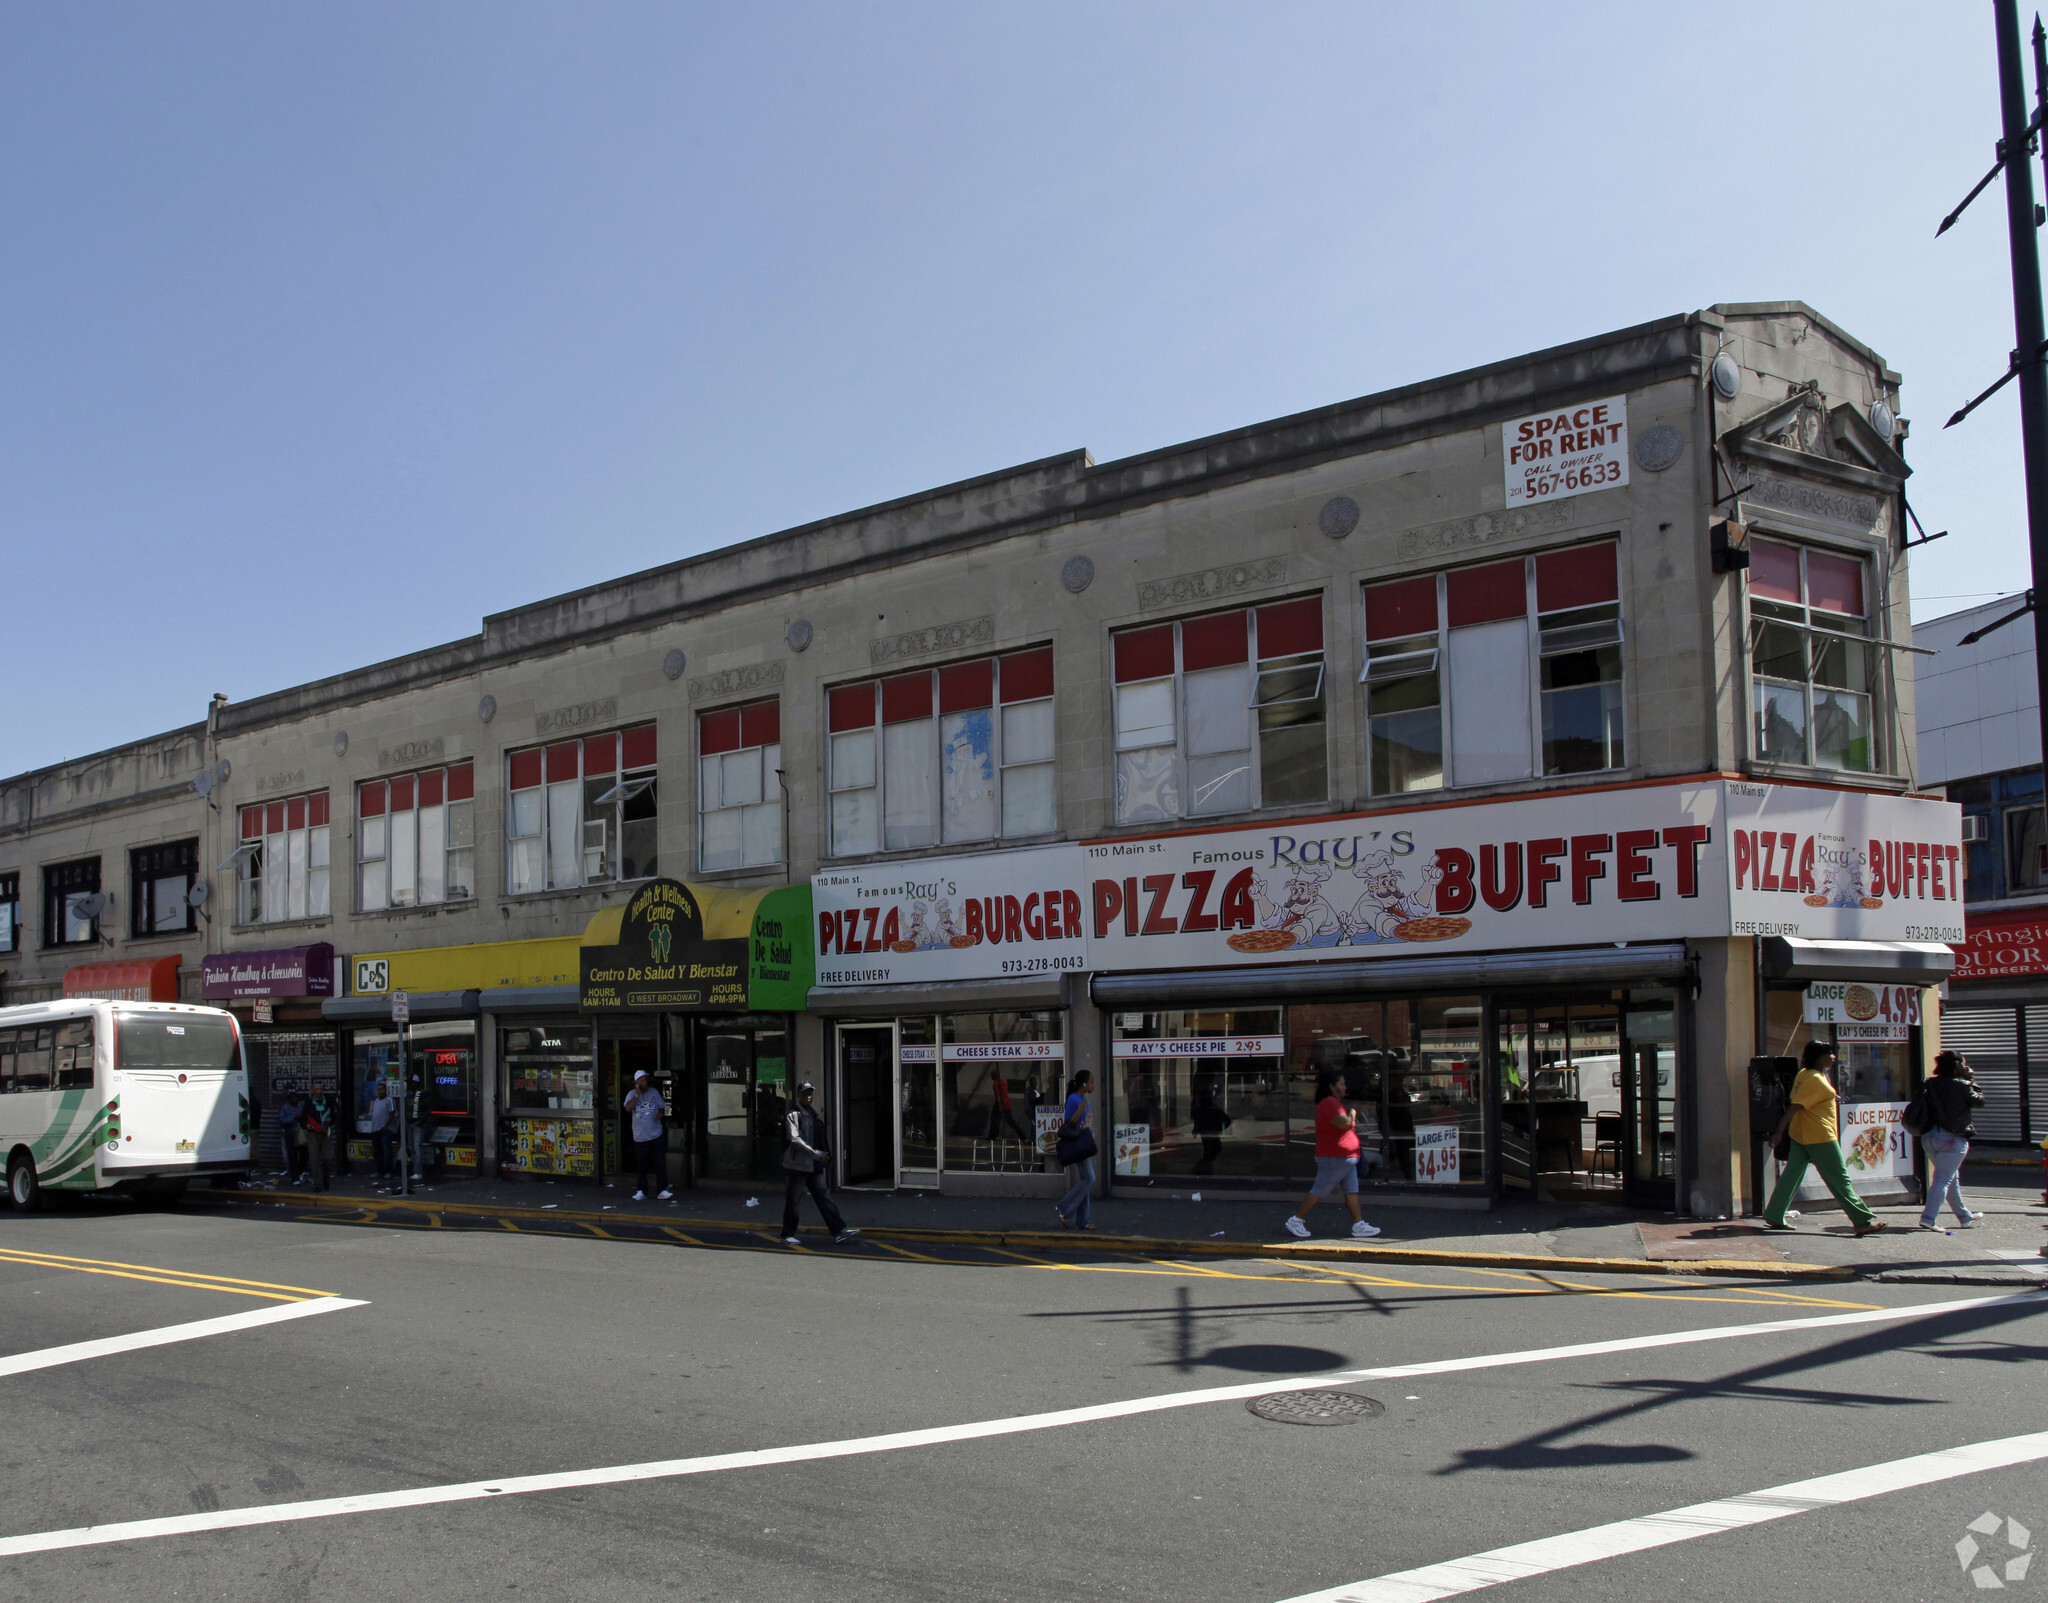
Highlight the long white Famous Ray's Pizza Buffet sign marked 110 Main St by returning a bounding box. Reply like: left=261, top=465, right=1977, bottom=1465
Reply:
left=1089, top=782, right=1729, bottom=970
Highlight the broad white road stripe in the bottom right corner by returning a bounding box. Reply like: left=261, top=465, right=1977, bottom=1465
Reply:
left=1286, top=1431, right=2048, bottom=1603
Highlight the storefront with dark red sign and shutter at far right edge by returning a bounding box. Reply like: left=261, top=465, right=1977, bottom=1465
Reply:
left=1942, top=907, right=2048, bottom=1146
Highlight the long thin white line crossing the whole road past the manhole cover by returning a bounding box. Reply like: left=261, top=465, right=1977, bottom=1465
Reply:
left=0, top=1292, right=2048, bottom=1558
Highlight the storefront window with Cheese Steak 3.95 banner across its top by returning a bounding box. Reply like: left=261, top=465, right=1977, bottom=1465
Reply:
left=942, top=1009, right=1064, bottom=1173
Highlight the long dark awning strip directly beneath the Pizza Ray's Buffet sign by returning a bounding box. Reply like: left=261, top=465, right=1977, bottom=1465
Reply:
left=1090, top=942, right=1688, bottom=1007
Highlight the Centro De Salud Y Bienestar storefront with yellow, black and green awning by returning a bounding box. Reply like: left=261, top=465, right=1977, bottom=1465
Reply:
left=581, top=880, right=811, bottom=1185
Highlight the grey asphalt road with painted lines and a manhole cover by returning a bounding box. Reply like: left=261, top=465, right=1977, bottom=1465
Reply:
left=0, top=1204, right=2048, bottom=1603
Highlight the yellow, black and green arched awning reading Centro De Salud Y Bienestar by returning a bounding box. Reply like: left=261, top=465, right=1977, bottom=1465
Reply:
left=580, top=880, right=813, bottom=1013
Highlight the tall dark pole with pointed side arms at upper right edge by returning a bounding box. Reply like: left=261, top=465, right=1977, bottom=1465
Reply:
left=1993, top=0, right=2048, bottom=794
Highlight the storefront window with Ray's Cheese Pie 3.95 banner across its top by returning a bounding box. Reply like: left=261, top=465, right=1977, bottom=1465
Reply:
left=1110, top=1007, right=1286, bottom=1179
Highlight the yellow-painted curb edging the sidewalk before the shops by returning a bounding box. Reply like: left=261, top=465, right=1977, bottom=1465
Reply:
left=219, top=1187, right=1862, bottom=1280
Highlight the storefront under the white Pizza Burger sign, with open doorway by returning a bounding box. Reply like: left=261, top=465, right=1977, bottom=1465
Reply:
left=811, top=846, right=1108, bottom=1196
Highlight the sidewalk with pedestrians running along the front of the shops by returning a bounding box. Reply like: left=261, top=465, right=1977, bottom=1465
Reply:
left=211, top=1167, right=2048, bottom=1286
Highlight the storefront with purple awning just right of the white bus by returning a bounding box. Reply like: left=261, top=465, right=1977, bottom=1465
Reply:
left=201, top=942, right=342, bottom=1171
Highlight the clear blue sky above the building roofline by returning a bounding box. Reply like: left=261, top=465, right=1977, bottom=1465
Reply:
left=0, top=0, right=2025, bottom=774
